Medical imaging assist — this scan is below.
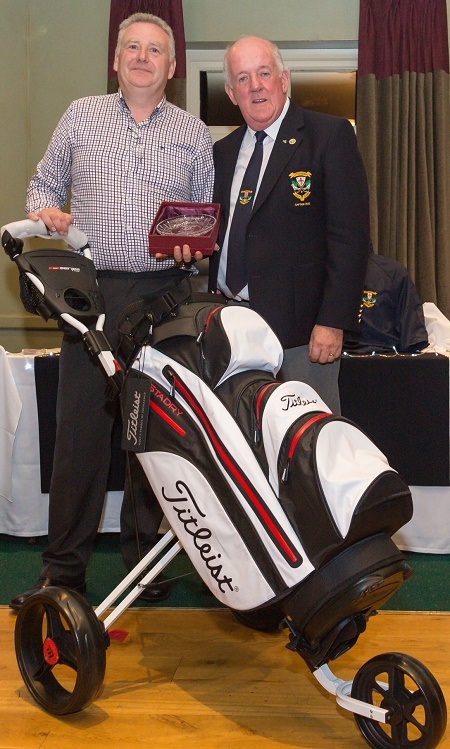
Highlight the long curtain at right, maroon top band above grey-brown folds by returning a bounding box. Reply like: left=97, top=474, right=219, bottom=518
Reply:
left=356, top=0, right=450, bottom=316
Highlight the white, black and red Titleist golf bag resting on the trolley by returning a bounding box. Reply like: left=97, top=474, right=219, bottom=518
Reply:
left=119, top=297, right=412, bottom=669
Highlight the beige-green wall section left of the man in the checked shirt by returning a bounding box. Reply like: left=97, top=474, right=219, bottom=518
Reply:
left=0, top=0, right=109, bottom=351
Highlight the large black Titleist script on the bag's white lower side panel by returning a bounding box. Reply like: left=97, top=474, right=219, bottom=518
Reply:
left=162, top=481, right=235, bottom=593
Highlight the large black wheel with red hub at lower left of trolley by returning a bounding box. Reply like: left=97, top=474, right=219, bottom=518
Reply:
left=15, top=587, right=107, bottom=715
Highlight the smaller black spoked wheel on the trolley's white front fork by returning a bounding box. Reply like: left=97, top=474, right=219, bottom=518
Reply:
left=352, top=653, right=447, bottom=749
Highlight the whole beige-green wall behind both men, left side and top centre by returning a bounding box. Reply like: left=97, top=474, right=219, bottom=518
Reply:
left=0, top=0, right=450, bottom=351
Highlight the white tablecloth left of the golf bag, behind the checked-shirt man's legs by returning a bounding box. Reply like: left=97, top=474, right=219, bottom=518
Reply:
left=0, top=347, right=122, bottom=537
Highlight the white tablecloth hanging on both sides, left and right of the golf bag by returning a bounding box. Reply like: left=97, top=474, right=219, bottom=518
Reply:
left=0, top=347, right=450, bottom=554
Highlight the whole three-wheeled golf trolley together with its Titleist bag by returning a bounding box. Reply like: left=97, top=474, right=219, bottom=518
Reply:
left=1, top=220, right=447, bottom=749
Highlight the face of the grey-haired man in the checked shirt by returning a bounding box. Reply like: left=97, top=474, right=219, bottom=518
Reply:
left=114, top=23, right=175, bottom=97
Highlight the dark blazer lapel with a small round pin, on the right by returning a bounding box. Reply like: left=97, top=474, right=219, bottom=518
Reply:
left=253, top=102, right=304, bottom=213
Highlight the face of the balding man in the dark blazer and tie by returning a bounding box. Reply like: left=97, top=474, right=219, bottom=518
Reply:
left=225, top=37, right=289, bottom=130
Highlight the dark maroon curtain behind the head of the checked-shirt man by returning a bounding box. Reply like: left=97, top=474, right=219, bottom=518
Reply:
left=108, top=0, right=186, bottom=108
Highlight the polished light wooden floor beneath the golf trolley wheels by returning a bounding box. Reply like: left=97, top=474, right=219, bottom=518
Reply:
left=0, top=607, right=450, bottom=749
